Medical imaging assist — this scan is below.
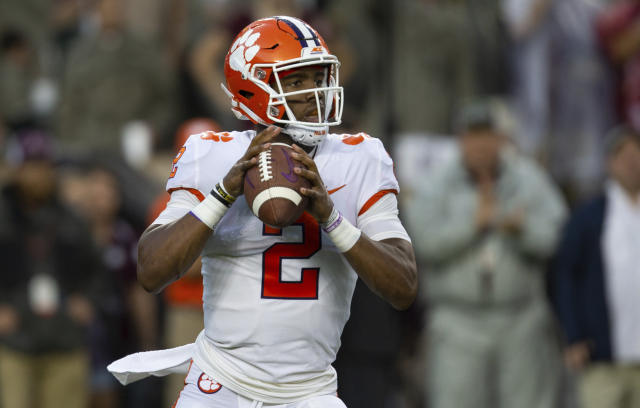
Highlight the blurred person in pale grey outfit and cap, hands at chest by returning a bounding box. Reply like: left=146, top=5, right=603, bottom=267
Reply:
left=407, top=99, right=565, bottom=408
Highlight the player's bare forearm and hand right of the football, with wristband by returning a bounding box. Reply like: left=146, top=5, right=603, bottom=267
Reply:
left=294, top=146, right=418, bottom=309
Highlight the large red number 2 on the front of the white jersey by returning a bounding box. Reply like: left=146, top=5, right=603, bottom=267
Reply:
left=262, top=213, right=321, bottom=299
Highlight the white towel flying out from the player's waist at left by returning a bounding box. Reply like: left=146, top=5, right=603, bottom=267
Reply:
left=107, top=343, right=195, bottom=385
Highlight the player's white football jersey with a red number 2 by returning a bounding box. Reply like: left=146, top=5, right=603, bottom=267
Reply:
left=162, top=131, right=399, bottom=402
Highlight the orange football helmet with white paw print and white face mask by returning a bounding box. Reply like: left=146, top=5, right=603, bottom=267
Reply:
left=221, top=16, right=343, bottom=145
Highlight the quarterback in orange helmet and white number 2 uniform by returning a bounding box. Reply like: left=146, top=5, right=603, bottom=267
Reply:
left=109, top=16, right=418, bottom=408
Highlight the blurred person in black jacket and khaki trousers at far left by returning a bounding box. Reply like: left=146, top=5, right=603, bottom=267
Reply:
left=0, top=131, right=102, bottom=408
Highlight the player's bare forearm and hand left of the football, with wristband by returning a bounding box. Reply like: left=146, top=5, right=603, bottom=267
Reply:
left=138, top=127, right=280, bottom=293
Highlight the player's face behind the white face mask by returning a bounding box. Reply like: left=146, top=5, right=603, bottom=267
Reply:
left=280, top=66, right=328, bottom=122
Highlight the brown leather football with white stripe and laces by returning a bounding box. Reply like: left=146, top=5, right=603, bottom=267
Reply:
left=244, top=143, right=311, bottom=228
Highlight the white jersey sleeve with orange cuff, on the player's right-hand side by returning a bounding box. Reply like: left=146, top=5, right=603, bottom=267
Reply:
left=357, top=136, right=400, bottom=216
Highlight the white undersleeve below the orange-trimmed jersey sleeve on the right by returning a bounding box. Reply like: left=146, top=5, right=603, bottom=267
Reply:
left=356, top=194, right=411, bottom=242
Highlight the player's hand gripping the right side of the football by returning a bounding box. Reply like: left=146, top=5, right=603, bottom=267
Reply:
left=291, top=144, right=333, bottom=223
